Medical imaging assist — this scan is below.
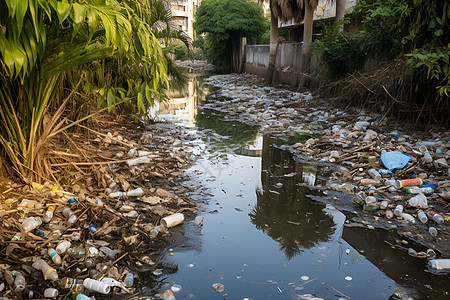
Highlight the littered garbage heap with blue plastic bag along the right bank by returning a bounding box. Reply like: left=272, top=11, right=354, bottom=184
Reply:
left=201, top=74, right=450, bottom=256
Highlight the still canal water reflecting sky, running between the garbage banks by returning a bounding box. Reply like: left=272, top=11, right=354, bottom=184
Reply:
left=142, top=73, right=449, bottom=299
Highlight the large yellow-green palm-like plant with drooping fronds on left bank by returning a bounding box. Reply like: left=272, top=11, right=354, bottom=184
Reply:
left=0, top=0, right=188, bottom=182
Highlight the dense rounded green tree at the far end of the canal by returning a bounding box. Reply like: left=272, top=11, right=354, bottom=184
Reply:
left=194, top=0, right=264, bottom=72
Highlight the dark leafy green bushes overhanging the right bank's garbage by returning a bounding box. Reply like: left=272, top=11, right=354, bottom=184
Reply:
left=316, top=0, right=450, bottom=123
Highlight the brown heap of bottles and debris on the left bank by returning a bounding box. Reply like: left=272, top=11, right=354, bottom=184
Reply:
left=0, top=124, right=195, bottom=299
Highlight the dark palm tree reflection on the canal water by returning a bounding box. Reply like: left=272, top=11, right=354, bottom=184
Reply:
left=249, top=136, right=336, bottom=259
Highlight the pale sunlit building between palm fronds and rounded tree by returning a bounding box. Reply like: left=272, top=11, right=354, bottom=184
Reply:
left=171, top=0, right=202, bottom=39
